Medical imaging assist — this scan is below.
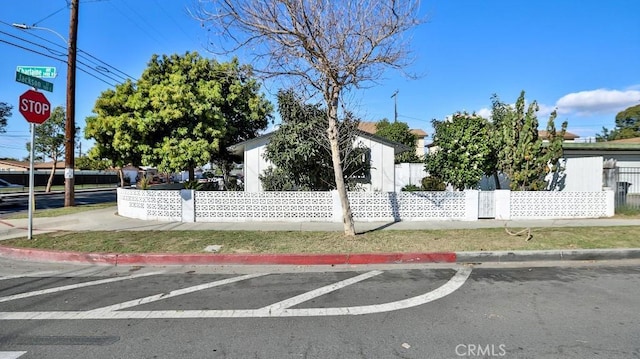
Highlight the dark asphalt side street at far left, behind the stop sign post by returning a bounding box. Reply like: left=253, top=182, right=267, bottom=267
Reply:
left=0, top=188, right=117, bottom=218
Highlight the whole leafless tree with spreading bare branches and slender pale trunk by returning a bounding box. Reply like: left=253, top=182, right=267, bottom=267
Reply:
left=193, top=0, right=421, bottom=236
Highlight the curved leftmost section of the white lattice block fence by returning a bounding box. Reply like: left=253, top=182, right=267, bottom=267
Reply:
left=118, top=188, right=182, bottom=221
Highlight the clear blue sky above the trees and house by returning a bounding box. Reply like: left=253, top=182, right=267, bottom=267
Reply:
left=0, top=0, right=640, bottom=159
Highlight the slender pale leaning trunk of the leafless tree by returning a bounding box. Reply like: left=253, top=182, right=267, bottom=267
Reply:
left=327, top=91, right=356, bottom=237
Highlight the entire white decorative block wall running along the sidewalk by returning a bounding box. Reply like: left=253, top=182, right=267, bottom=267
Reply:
left=118, top=188, right=614, bottom=222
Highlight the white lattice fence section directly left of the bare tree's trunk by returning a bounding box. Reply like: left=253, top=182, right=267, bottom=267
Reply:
left=195, top=191, right=334, bottom=222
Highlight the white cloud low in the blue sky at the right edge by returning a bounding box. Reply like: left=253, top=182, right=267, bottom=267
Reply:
left=556, top=89, right=640, bottom=116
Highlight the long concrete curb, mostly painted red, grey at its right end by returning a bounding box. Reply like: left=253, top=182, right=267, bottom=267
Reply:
left=0, top=246, right=640, bottom=266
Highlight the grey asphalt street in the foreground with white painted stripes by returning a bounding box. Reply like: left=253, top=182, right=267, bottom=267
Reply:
left=0, top=260, right=640, bottom=359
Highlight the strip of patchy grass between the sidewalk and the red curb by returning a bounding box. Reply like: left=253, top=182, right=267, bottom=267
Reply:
left=1, top=226, right=640, bottom=253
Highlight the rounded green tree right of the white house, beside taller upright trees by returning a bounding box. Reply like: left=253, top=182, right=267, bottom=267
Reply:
left=425, top=112, right=492, bottom=190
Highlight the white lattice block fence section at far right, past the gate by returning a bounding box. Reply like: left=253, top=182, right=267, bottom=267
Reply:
left=510, top=191, right=612, bottom=219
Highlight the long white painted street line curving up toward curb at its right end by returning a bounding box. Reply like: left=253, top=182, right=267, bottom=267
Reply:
left=0, top=267, right=471, bottom=320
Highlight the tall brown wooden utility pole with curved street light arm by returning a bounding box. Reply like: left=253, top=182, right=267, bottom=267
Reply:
left=12, top=0, right=80, bottom=207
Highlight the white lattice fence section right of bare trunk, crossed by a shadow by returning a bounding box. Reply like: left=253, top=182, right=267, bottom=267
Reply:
left=349, top=192, right=470, bottom=221
